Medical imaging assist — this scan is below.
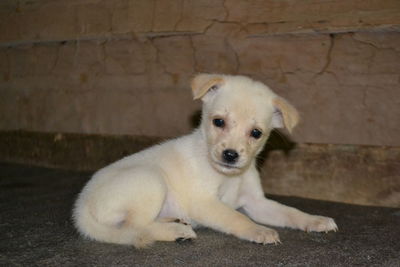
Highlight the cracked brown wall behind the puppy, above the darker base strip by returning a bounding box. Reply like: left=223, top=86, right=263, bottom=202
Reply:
left=0, top=0, right=400, bottom=146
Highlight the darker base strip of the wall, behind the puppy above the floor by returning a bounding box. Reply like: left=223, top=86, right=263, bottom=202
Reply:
left=0, top=131, right=400, bottom=207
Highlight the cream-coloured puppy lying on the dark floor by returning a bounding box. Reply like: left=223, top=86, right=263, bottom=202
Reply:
left=73, top=74, right=337, bottom=248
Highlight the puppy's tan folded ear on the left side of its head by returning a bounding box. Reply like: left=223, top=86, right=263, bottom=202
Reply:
left=191, top=73, right=224, bottom=100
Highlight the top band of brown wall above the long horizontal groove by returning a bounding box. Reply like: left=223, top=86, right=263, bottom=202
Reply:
left=0, top=0, right=400, bottom=43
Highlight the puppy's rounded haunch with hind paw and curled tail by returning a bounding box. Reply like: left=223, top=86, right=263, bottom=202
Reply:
left=73, top=168, right=196, bottom=248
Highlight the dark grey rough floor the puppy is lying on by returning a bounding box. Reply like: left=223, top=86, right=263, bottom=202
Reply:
left=0, top=163, right=400, bottom=266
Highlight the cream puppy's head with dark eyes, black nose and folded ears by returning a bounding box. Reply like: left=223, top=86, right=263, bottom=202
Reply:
left=192, top=74, right=299, bottom=175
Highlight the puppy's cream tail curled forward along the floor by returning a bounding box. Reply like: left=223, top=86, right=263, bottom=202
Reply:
left=72, top=199, right=155, bottom=248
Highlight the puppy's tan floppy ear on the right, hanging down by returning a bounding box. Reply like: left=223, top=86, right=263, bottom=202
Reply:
left=271, top=96, right=300, bottom=133
